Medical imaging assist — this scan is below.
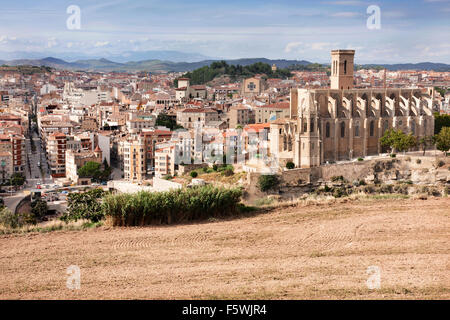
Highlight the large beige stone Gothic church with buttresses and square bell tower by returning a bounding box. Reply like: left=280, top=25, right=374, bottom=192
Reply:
left=270, top=50, right=434, bottom=168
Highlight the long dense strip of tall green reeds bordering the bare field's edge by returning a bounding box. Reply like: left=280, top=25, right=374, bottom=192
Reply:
left=102, top=186, right=242, bottom=226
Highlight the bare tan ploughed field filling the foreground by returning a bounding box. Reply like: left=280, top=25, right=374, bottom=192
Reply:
left=0, top=198, right=450, bottom=299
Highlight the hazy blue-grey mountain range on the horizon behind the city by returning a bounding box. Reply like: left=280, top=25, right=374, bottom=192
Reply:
left=0, top=53, right=450, bottom=72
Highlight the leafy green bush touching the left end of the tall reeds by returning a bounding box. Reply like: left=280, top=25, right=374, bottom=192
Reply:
left=60, top=189, right=105, bottom=222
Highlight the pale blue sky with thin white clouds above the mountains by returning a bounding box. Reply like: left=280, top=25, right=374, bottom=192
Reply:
left=0, top=0, right=450, bottom=64
